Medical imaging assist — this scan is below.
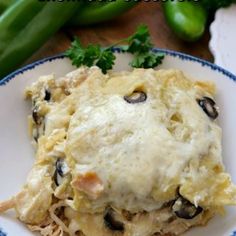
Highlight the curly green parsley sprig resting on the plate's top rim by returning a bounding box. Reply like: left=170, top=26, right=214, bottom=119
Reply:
left=65, top=25, right=164, bottom=73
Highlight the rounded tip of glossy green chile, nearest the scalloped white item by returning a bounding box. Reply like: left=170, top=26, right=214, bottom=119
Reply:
left=163, top=0, right=208, bottom=42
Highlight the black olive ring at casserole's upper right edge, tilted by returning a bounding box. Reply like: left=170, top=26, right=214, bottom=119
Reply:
left=197, top=97, right=219, bottom=119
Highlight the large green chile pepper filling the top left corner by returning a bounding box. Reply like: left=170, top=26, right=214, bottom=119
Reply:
left=0, top=0, right=80, bottom=79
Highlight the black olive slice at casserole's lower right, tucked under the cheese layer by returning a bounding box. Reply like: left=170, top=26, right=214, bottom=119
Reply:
left=172, top=196, right=203, bottom=220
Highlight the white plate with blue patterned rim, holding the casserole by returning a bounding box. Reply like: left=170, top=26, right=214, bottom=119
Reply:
left=0, top=49, right=236, bottom=236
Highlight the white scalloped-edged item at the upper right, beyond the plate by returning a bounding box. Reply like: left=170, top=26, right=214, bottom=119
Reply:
left=210, top=4, right=236, bottom=75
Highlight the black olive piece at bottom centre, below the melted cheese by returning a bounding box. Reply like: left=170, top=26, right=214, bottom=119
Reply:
left=104, top=208, right=124, bottom=231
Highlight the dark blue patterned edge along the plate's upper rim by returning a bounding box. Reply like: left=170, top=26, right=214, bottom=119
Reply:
left=0, top=47, right=236, bottom=86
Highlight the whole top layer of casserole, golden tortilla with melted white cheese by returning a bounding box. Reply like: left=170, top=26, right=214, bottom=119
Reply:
left=24, top=68, right=236, bottom=218
